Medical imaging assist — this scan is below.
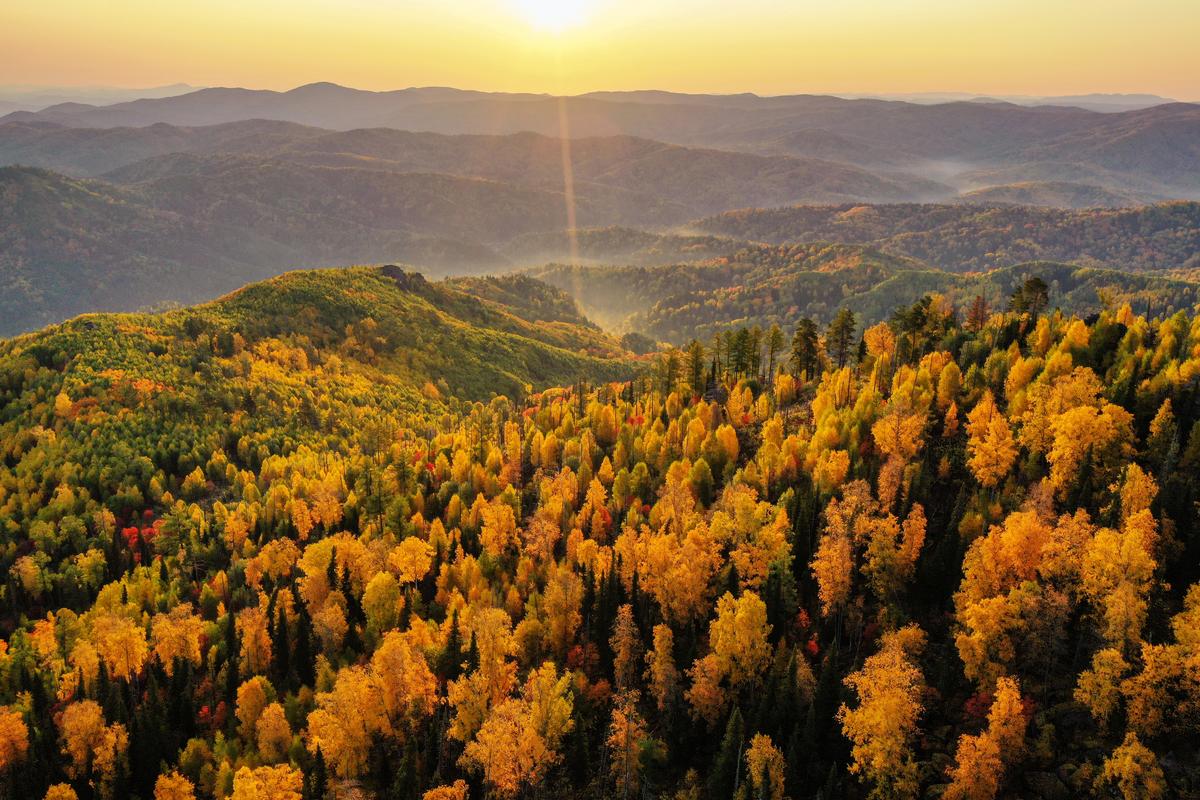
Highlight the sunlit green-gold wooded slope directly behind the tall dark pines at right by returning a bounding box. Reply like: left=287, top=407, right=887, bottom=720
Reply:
left=529, top=243, right=1200, bottom=345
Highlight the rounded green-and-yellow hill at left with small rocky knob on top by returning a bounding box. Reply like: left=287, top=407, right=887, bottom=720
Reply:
left=2, top=266, right=630, bottom=412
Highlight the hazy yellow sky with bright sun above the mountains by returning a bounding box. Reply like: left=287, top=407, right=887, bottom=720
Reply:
left=0, top=0, right=1200, bottom=100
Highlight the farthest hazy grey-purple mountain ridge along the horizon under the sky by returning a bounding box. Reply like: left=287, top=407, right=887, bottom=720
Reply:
left=9, top=83, right=1200, bottom=207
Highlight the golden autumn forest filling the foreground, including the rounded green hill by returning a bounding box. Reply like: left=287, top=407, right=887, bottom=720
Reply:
left=0, top=272, right=1200, bottom=800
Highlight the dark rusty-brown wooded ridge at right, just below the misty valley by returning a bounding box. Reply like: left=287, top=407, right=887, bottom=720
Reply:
left=689, top=203, right=1200, bottom=272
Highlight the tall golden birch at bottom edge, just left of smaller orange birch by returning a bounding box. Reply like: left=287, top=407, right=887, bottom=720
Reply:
left=838, top=626, right=925, bottom=800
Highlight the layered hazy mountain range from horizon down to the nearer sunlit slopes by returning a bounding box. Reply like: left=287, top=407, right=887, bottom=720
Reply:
left=7, top=84, right=1200, bottom=333
